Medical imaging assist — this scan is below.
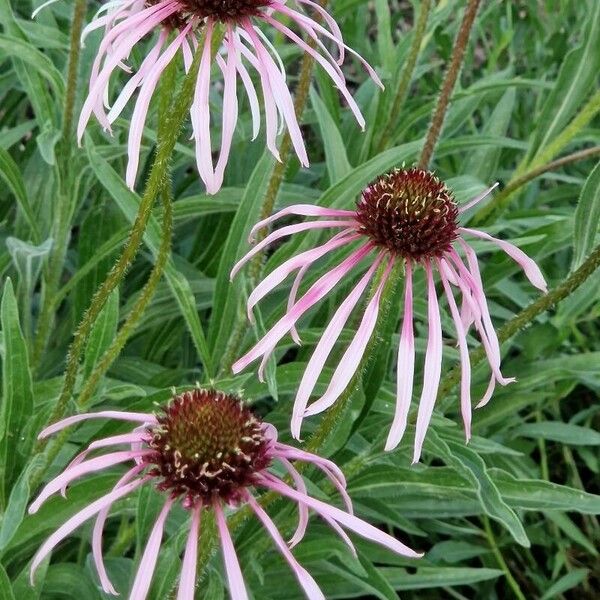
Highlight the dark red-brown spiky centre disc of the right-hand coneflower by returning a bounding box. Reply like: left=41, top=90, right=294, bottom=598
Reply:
left=356, top=168, right=458, bottom=260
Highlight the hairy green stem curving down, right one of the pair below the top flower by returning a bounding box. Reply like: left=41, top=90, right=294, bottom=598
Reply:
left=77, top=184, right=173, bottom=409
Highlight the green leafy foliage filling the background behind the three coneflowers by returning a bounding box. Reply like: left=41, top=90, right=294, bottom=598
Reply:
left=0, top=0, right=600, bottom=600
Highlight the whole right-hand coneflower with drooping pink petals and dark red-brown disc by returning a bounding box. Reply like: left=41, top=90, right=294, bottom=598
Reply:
left=232, top=169, right=546, bottom=462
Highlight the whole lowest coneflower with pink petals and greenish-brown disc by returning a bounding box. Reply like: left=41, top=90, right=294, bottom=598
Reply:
left=29, top=389, right=421, bottom=600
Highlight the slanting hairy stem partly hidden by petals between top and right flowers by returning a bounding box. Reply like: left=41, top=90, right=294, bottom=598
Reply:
left=219, top=0, right=327, bottom=377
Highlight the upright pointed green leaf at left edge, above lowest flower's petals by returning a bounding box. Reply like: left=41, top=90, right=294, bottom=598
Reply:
left=0, top=279, right=33, bottom=506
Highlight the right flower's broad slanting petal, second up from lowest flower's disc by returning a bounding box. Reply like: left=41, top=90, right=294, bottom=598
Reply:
left=304, top=259, right=394, bottom=416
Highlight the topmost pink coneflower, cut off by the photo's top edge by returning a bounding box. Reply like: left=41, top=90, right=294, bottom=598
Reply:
left=78, top=0, right=381, bottom=194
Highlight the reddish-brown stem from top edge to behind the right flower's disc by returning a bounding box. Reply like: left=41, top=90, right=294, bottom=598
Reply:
left=419, top=0, right=480, bottom=169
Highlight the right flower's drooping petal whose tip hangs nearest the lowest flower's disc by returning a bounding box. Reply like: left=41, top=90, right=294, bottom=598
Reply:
left=291, top=254, right=383, bottom=439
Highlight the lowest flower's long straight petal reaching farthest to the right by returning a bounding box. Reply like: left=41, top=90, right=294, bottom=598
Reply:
left=262, top=476, right=423, bottom=558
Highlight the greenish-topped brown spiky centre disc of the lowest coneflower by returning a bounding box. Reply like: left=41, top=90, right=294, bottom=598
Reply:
left=148, top=389, right=270, bottom=503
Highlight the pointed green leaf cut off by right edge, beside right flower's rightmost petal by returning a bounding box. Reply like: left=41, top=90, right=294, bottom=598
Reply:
left=571, top=163, right=600, bottom=270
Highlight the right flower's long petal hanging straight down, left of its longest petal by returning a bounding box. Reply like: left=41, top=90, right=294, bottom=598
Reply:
left=385, top=259, right=415, bottom=451
